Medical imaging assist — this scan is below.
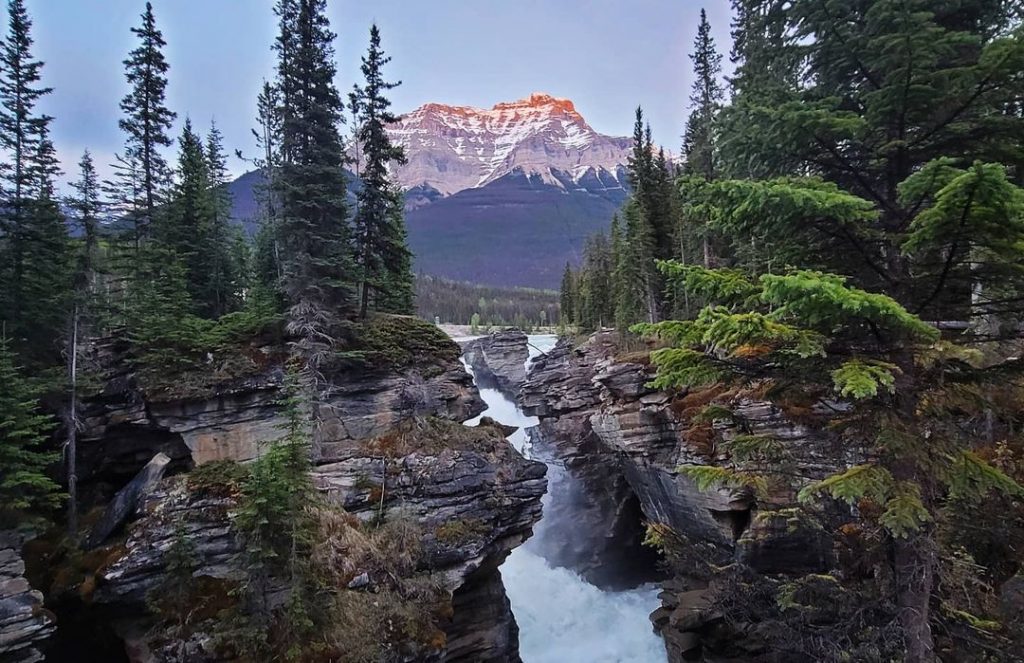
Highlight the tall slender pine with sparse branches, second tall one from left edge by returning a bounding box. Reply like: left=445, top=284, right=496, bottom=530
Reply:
left=119, top=2, right=175, bottom=253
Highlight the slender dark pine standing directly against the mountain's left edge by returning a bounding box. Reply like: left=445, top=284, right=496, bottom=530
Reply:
left=352, top=25, right=413, bottom=318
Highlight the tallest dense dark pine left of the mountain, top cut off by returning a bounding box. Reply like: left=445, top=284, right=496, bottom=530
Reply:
left=273, top=0, right=355, bottom=364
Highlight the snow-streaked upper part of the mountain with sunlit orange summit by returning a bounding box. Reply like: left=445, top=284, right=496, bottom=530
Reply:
left=378, top=92, right=630, bottom=196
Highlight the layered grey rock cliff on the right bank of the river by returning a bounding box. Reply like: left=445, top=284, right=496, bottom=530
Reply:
left=521, top=333, right=857, bottom=661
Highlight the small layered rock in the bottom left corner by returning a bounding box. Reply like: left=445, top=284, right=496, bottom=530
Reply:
left=0, top=531, right=56, bottom=663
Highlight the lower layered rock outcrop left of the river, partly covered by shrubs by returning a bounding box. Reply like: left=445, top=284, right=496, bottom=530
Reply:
left=93, top=423, right=546, bottom=663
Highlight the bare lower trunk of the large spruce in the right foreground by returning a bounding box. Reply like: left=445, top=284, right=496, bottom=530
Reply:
left=893, top=533, right=936, bottom=663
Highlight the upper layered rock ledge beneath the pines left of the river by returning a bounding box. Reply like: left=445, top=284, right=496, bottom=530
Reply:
left=80, top=340, right=484, bottom=483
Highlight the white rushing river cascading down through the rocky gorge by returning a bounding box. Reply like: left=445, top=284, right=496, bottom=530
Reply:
left=466, top=334, right=667, bottom=663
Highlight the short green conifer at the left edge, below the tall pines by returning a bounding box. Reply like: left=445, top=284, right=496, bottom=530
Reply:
left=0, top=334, right=60, bottom=528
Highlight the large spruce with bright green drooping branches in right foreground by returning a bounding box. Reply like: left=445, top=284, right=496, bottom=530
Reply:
left=656, top=0, right=1024, bottom=662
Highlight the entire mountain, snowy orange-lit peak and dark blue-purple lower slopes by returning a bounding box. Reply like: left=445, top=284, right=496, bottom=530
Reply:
left=230, top=93, right=631, bottom=288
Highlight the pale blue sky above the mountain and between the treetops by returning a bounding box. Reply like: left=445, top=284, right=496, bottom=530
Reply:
left=27, top=0, right=729, bottom=185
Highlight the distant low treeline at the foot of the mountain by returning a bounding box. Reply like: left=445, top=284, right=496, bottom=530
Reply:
left=416, top=275, right=559, bottom=327
